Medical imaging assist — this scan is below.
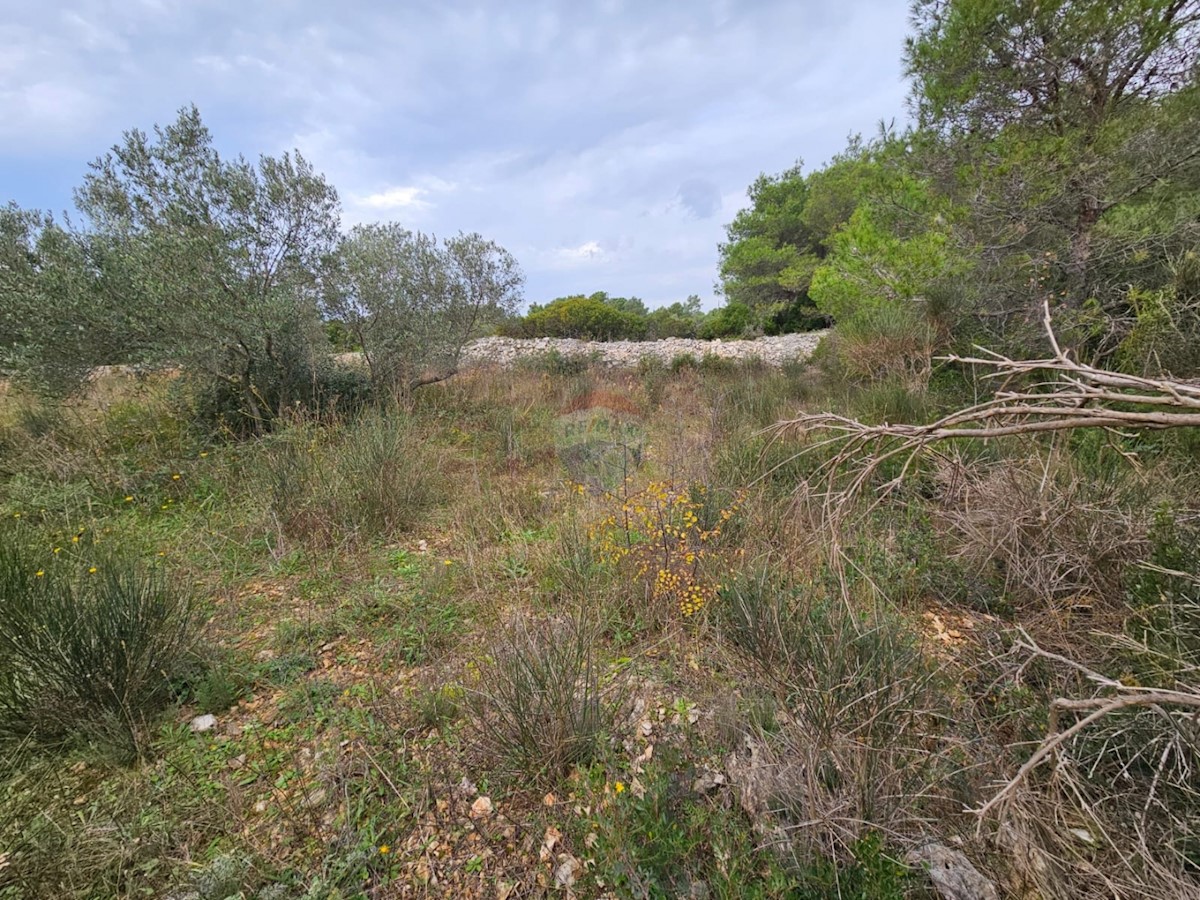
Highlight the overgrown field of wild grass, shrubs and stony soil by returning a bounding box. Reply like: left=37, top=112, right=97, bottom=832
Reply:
left=0, top=360, right=1200, bottom=900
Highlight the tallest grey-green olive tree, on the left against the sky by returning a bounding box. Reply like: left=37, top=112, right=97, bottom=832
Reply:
left=58, top=107, right=338, bottom=430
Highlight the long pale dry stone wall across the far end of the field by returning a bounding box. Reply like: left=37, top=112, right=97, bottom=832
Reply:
left=461, top=331, right=826, bottom=368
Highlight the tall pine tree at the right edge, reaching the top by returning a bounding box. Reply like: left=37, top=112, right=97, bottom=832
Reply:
left=906, top=0, right=1200, bottom=340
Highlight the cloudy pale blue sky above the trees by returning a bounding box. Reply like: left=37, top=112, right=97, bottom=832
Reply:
left=0, top=0, right=908, bottom=307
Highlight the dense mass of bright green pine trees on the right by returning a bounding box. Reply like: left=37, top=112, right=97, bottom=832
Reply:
left=720, top=0, right=1200, bottom=368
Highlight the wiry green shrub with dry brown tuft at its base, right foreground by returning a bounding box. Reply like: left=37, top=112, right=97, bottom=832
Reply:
left=719, top=569, right=946, bottom=860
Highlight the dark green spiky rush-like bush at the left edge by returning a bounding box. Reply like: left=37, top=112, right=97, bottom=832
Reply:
left=0, top=532, right=199, bottom=758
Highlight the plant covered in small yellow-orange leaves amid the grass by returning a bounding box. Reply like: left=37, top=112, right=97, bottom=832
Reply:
left=588, top=481, right=742, bottom=616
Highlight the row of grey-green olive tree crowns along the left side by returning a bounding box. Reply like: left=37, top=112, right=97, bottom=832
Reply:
left=0, top=107, right=522, bottom=430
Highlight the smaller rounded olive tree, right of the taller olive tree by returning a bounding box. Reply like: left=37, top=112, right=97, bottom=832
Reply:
left=325, top=222, right=524, bottom=392
